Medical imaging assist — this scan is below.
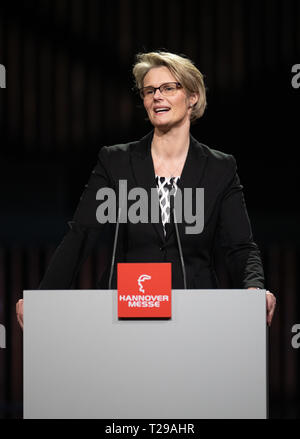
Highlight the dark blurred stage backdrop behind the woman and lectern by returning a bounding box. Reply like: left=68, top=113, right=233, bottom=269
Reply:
left=0, top=0, right=300, bottom=418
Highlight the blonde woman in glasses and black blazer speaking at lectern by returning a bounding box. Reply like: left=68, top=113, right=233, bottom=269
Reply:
left=17, top=52, right=276, bottom=326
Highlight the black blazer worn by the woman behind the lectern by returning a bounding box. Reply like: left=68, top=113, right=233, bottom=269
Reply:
left=39, top=132, right=264, bottom=289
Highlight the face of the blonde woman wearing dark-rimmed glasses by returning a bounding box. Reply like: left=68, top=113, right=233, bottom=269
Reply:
left=144, top=66, right=198, bottom=130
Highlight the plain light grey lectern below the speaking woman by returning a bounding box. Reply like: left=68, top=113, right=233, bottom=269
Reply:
left=23, top=290, right=268, bottom=419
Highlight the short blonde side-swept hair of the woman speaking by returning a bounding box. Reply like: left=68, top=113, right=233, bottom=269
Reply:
left=132, top=51, right=207, bottom=122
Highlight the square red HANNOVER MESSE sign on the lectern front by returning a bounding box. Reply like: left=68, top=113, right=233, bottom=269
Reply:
left=118, top=263, right=171, bottom=318
